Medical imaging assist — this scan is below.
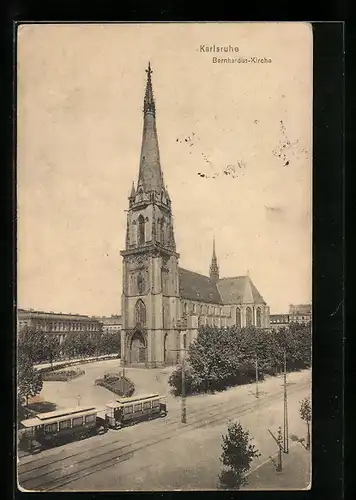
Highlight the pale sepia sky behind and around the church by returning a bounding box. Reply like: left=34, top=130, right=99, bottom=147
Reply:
left=17, top=23, right=312, bottom=315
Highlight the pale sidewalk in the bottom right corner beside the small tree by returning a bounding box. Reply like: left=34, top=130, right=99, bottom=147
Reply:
left=241, top=443, right=311, bottom=490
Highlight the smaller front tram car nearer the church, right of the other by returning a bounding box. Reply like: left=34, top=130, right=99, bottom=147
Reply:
left=105, top=394, right=168, bottom=429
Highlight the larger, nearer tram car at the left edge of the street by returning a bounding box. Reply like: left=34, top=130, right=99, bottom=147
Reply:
left=19, top=406, right=107, bottom=453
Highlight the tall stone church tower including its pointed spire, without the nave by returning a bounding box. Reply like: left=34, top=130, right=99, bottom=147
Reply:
left=121, top=63, right=180, bottom=368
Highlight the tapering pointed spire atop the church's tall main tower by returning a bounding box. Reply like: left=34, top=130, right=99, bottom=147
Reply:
left=137, top=63, right=165, bottom=193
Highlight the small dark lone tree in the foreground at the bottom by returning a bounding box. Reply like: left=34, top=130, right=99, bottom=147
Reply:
left=219, top=422, right=261, bottom=490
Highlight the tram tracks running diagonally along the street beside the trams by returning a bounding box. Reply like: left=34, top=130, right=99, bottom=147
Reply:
left=18, top=382, right=309, bottom=491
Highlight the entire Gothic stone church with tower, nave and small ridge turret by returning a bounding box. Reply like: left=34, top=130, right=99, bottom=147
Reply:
left=121, top=64, right=269, bottom=368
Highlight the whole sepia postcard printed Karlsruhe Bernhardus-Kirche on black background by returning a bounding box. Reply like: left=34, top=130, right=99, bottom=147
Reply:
left=17, top=22, right=313, bottom=492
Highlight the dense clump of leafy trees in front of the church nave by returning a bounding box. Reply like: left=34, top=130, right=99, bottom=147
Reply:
left=169, top=324, right=311, bottom=395
